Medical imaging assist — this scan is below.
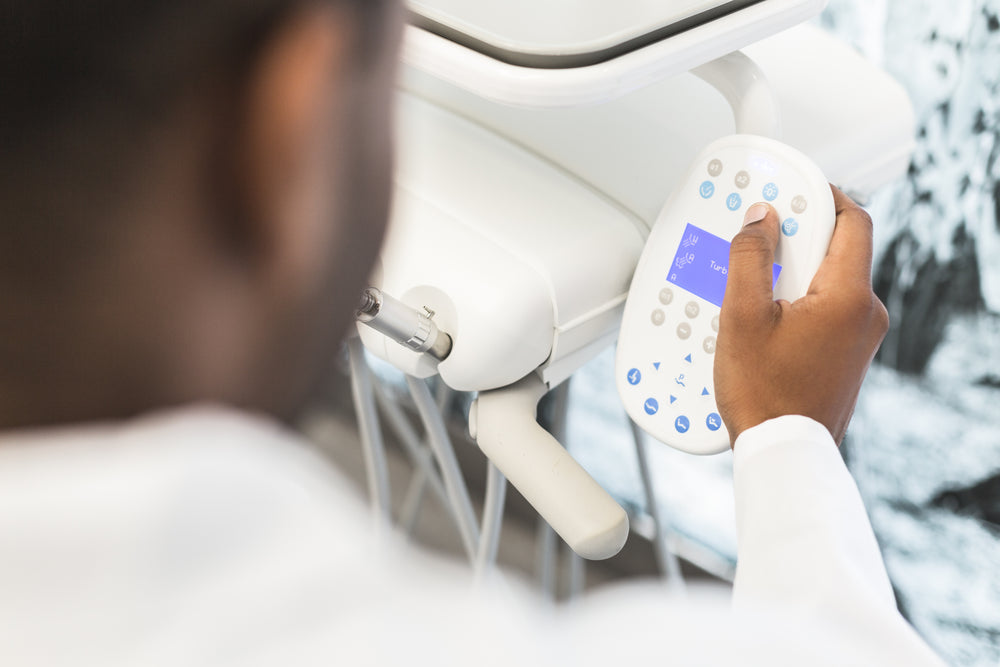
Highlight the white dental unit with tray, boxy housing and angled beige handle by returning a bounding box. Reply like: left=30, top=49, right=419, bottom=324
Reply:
left=355, top=0, right=914, bottom=559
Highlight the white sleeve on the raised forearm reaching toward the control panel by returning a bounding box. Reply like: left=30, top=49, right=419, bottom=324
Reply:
left=733, top=416, right=940, bottom=665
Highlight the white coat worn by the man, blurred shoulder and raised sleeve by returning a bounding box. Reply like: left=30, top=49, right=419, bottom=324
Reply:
left=0, top=407, right=939, bottom=666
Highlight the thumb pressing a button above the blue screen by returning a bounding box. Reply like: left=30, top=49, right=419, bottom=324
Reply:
left=722, top=203, right=778, bottom=322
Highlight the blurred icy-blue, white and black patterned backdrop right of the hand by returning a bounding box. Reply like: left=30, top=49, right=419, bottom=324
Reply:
left=823, top=0, right=1000, bottom=665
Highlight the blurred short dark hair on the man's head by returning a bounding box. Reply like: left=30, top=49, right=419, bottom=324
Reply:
left=0, top=0, right=394, bottom=275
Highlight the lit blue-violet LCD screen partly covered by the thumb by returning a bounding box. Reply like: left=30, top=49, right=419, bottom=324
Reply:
left=667, top=223, right=781, bottom=308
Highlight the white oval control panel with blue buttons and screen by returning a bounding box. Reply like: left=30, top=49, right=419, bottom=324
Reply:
left=615, top=135, right=836, bottom=454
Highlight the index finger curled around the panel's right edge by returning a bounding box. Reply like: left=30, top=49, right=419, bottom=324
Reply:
left=809, top=185, right=872, bottom=292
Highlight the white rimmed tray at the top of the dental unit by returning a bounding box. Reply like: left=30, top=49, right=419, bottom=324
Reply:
left=403, top=0, right=826, bottom=108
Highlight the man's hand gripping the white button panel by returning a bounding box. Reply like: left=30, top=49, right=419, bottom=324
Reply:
left=715, top=186, right=889, bottom=445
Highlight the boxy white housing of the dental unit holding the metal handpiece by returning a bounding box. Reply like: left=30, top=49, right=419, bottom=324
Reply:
left=359, top=96, right=645, bottom=391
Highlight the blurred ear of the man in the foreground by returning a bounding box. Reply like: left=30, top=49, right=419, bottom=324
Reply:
left=233, top=7, right=353, bottom=294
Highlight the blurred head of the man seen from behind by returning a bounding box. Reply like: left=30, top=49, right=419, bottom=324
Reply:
left=0, top=0, right=400, bottom=427
